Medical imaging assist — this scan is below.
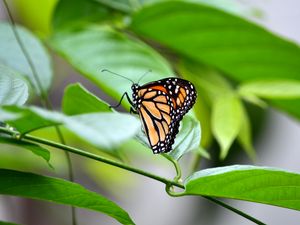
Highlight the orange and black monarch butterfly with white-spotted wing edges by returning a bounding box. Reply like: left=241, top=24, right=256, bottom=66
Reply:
left=102, top=70, right=197, bottom=154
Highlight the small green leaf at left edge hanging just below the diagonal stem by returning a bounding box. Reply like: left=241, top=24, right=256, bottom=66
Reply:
left=0, top=136, right=53, bottom=168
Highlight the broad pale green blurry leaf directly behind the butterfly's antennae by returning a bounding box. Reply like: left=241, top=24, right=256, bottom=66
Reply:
left=51, top=26, right=173, bottom=109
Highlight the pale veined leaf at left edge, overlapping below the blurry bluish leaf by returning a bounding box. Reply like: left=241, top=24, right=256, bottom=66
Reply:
left=0, top=64, right=28, bottom=105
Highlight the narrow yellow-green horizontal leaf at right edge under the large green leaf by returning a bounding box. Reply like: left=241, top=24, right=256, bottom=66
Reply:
left=239, top=80, right=300, bottom=99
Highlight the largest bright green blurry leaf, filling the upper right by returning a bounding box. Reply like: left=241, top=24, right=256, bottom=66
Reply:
left=130, top=1, right=300, bottom=118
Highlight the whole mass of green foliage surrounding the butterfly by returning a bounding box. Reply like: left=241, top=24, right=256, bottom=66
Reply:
left=0, top=0, right=300, bottom=224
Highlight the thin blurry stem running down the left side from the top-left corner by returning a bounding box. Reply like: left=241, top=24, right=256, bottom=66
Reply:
left=3, top=0, right=77, bottom=225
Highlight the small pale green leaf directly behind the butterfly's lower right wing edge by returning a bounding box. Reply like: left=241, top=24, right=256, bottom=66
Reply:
left=169, top=116, right=201, bottom=160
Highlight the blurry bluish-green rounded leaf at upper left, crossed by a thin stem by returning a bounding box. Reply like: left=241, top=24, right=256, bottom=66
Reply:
left=0, top=22, right=53, bottom=93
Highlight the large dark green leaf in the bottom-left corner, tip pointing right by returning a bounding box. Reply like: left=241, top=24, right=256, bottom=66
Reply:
left=0, top=169, right=134, bottom=224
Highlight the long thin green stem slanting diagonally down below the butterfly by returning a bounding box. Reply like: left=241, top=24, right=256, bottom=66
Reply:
left=0, top=127, right=264, bottom=225
